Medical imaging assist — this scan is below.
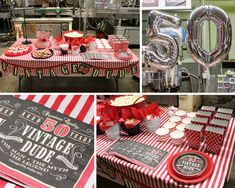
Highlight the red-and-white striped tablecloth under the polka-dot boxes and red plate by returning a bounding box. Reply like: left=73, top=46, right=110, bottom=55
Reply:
left=96, top=110, right=235, bottom=188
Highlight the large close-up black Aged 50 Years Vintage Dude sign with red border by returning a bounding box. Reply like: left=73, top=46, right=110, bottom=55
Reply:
left=0, top=96, right=94, bottom=188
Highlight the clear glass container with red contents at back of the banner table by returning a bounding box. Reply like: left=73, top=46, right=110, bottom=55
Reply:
left=35, top=30, right=51, bottom=48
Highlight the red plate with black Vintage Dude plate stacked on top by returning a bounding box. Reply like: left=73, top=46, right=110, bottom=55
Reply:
left=167, top=150, right=214, bottom=184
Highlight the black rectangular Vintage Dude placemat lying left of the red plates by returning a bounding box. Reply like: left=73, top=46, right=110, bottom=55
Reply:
left=106, top=140, right=167, bottom=169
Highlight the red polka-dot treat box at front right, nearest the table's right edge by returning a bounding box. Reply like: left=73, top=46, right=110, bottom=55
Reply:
left=205, top=126, right=225, bottom=154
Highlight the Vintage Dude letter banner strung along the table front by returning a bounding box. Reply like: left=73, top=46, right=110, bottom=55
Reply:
left=1, top=61, right=138, bottom=79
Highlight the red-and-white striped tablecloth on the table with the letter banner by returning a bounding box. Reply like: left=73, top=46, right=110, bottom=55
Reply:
left=0, top=39, right=139, bottom=76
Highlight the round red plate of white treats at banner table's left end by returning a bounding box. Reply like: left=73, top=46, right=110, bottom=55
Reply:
left=4, top=44, right=32, bottom=57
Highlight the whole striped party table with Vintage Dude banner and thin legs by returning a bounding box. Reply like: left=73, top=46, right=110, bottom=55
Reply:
left=0, top=39, right=139, bottom=90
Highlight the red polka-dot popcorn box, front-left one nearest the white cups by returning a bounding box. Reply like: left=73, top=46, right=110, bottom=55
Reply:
left=185, top=123, right=203, bottom=149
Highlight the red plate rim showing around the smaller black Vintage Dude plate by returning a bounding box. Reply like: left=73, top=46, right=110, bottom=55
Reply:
left=167, top=150, right=214, bottom=184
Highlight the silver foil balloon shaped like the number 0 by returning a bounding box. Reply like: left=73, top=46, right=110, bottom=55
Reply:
left=187, top=6, right=232, bottom=67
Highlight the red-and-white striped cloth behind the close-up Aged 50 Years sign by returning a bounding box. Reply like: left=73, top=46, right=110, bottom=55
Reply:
left=0, top=95, right=95, bottom=188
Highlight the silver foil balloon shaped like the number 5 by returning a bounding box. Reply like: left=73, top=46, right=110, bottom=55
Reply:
left=145, top=11, right=181, bottom=69
